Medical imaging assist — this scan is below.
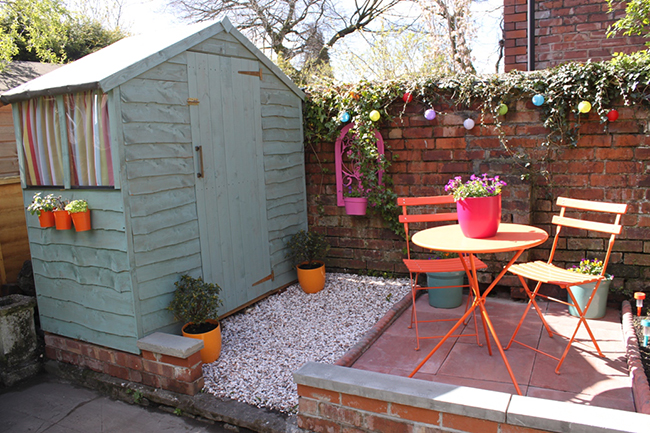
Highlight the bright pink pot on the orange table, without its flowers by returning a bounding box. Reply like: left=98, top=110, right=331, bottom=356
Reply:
left=456, top=195, right=501, bottom=239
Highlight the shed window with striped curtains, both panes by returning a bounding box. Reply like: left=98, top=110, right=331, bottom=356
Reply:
left=19, top=91, right=115, bottom=186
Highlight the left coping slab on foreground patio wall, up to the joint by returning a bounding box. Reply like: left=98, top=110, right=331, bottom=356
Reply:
left=293, top=362, right=512, bottom=422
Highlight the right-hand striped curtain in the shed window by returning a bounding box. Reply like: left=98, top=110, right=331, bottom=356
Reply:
left=64, top=92, right=114, bottom=186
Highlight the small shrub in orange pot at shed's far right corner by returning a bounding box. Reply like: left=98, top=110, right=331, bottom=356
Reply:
left=288, top=230, right=330, bottom=293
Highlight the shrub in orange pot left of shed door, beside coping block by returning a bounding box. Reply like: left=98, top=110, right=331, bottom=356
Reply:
left=168, top=275, right=223, bottom=363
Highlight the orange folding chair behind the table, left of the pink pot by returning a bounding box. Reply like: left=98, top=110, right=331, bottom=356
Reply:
left=397, top=195, right=487, bottom=350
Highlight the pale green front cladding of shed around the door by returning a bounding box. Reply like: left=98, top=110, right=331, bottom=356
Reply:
left=119, top=32, right=307, bottom=335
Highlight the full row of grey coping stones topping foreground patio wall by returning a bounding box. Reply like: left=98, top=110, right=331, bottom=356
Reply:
left=294, top=362, right=650, bottom=433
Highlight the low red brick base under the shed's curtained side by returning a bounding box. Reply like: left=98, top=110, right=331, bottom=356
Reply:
left=45, top=333, right=203, bottom=395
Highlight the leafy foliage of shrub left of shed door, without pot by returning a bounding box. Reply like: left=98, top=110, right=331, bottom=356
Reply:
left=168, top=275, right=223, bottom=325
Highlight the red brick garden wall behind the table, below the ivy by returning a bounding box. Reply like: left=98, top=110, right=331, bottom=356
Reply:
left=305, top=97, right=650, bottom=291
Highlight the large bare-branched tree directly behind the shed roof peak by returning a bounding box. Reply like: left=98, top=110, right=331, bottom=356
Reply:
left=169, top=0, right=405, bottom=67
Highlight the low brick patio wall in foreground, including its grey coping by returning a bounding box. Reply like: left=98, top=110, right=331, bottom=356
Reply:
left=294, top=362, right=650, bottom=433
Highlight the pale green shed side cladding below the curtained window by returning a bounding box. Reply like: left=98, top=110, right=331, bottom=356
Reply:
left=23, top=188, right=138, bottom=352
